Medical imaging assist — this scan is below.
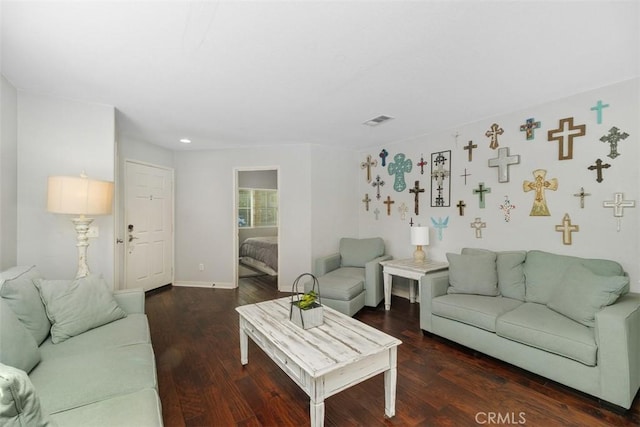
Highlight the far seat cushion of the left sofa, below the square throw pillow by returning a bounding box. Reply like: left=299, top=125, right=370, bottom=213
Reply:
left=40, top=314, right=151, bottom=361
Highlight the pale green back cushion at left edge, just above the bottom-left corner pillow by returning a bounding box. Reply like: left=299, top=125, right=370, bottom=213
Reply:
left=0, top=298, right=40, bottom=372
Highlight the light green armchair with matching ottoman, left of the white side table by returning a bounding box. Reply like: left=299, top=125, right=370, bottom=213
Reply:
left=304, top=237, right=392, bottom=316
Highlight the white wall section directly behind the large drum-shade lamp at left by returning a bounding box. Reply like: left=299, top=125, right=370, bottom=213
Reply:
left=17, top=91, right=115, bottom=283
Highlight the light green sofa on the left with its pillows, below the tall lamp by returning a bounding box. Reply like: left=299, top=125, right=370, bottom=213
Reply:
left=0, top=267, right=162, bottom=426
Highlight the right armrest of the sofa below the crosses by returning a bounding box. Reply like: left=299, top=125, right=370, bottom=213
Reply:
left=595, top=293, right=640, bottom=409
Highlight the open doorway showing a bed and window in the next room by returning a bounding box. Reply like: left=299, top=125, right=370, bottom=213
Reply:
left=233, top=167, right=280, bottom=287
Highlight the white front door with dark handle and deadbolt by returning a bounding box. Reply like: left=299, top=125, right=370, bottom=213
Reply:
left=123, top=161, right=173, bottom=291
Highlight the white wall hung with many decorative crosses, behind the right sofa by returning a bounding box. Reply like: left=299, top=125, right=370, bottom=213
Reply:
left=360, top=79, right=640, bottom=291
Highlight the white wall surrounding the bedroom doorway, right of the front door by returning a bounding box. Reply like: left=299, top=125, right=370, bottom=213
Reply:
left=175, top=145, right=311, bottom=289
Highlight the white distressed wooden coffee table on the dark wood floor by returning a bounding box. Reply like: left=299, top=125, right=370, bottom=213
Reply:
left=236, top=297, right=402, bottom=427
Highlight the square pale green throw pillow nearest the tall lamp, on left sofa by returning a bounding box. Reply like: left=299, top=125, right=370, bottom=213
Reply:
left=34, top=275, right=127, bottom=344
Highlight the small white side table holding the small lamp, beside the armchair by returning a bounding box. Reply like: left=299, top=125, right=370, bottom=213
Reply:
left=380, top=258, right=449, bottom=310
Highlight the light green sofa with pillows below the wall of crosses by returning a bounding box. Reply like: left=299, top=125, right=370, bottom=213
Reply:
left=420, top=248, right=640, bottom=409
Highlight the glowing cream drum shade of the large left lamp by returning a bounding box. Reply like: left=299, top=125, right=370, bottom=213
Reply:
left=47, top=176, right=113, bottom=215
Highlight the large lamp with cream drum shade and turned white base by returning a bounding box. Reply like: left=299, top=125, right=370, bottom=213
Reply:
left=47, top=173, right=113, bottom=279
